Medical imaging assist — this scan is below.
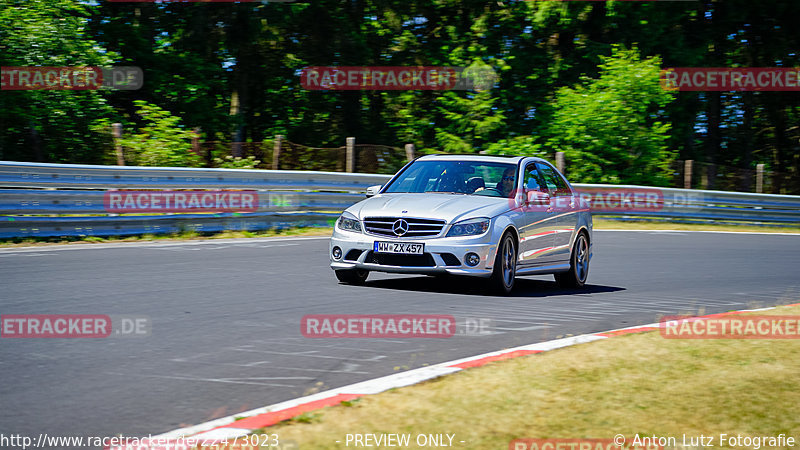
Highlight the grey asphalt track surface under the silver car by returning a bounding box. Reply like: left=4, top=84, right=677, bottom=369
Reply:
left=0, top=231, right=800, bottom=447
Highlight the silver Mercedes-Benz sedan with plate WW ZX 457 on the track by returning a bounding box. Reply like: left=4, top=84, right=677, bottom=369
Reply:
left=330, top=155, right=592, bottom=294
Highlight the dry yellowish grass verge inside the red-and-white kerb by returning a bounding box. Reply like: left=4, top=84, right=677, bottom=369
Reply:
left=259, top=307, right=800, bottom=449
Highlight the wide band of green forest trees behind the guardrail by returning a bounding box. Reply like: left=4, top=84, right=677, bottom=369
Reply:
left=0, top=0, right=800, bottom=192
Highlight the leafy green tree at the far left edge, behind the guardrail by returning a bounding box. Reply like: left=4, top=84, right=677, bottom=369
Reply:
left=0, top=0, right=117, bottom=163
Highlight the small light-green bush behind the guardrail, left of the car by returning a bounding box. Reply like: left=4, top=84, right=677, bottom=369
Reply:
left=115, top=100, right=202, bottom=167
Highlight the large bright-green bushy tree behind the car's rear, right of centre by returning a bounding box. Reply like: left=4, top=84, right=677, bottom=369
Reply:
left=548, top=47, right=675, bottom=185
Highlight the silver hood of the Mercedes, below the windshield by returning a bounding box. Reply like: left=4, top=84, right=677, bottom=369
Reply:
left=347, top=193, right=512, bottom=223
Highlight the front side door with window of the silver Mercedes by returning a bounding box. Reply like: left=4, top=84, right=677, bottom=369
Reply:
left=519, top=163, right=558, bottom=266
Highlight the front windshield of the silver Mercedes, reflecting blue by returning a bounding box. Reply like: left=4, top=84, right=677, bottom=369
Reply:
left=383, top=161, right=517, bottom=197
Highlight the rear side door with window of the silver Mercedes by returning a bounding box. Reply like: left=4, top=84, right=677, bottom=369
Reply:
left=536, top=162, right=578, bottom=262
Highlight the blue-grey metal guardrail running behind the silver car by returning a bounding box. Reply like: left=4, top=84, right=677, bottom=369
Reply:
left=0, top=162, right=800, bottom=238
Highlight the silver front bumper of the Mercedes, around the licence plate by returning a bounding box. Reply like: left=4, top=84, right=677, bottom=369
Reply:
left=328, top=228, right=497, bottom=277
